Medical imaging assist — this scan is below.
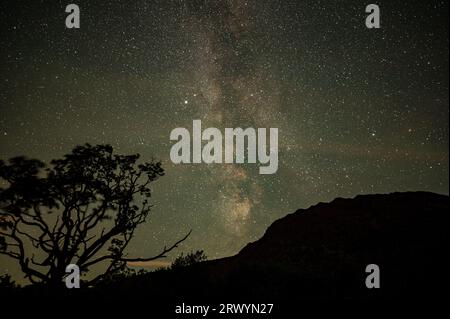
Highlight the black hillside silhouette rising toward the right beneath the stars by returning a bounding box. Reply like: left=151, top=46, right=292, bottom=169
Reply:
left=2, top=192, right=449, bottom=308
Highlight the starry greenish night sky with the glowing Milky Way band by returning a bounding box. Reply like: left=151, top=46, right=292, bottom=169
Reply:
left=0, top=0, right=449, bottom=280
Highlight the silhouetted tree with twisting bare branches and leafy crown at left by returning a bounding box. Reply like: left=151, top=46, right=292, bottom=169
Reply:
left=0, top=144, right=190, bottom=286
